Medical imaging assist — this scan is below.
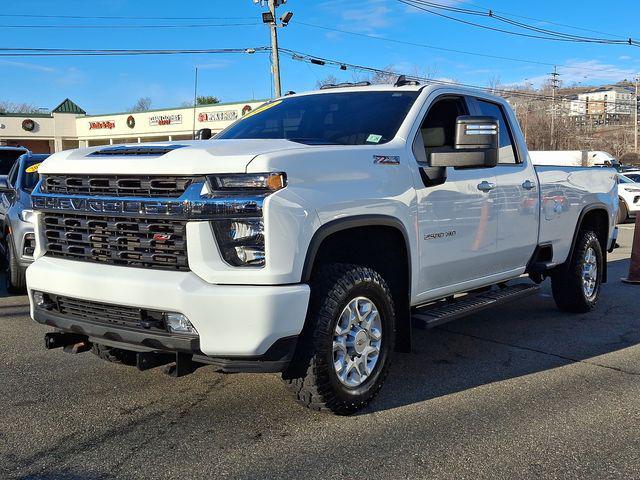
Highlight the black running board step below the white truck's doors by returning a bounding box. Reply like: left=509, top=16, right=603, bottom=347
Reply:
left=411, top=283, right=540, bottom=329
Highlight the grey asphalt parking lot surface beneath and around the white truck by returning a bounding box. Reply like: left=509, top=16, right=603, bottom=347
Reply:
left=0, top=225, right=640, bottom=480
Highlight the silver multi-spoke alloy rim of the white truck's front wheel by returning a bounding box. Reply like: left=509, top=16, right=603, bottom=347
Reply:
left=333, top=297, right=382, bottom=388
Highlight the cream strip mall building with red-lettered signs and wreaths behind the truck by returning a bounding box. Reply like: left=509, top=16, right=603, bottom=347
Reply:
left=0, top=99, right=264, bottom=153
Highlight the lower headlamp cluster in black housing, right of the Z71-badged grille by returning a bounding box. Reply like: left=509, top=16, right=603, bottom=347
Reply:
left=211, top=218, right=265, bottom=267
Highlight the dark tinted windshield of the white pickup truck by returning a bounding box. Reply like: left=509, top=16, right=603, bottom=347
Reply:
left=215, top=91, right=419, bottom=145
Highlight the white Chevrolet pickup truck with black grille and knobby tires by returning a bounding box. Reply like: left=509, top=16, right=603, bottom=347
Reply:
left=27, top=79, right=618, bottom=414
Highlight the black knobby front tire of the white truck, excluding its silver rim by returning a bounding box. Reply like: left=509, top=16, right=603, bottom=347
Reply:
left=283, top=263, right=395, bottom=415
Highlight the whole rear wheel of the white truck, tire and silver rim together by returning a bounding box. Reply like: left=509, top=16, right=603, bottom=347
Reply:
left=551, top=230, right=604, bottom=313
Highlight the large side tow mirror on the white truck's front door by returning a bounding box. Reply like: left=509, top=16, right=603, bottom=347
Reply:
left=430, top=115, right=500, bottom=168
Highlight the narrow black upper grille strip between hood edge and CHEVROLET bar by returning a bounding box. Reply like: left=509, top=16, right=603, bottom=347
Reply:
left=40, top=175, right=204, bottom=198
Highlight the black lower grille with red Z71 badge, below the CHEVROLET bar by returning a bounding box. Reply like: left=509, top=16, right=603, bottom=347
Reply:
left=42, top=212, right=189, bottom=271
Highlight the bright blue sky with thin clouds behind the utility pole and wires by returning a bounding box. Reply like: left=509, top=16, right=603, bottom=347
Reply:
left=0, top=0, right=640, bottom=114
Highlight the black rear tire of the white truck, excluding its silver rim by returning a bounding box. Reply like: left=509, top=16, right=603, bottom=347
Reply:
left=551, top=230, right=605, bottom=313
